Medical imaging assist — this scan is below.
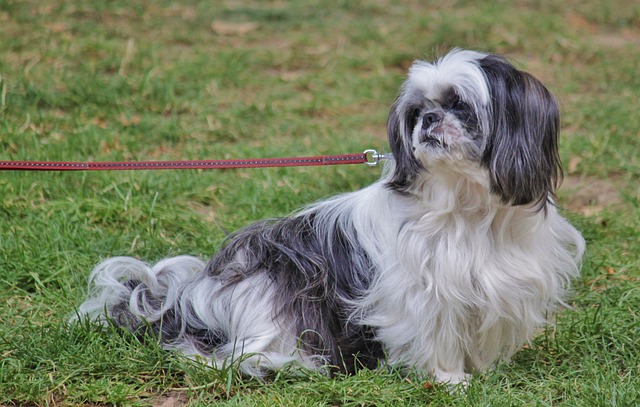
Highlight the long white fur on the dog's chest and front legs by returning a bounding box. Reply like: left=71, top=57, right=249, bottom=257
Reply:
left=302, top=170, right=584, bottom=382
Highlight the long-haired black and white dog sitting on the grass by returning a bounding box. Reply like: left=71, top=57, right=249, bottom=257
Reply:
left=76, top=49, right=584, bottom=383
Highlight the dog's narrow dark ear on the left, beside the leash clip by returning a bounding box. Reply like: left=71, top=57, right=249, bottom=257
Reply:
left=387, top=96, right=422, bottom=193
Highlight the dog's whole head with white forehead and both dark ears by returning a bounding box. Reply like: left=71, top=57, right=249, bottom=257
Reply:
left=388, top=50, right=561, bottom=209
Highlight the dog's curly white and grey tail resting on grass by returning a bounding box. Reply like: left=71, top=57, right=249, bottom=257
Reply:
left=72, top=256, right=205, bottom=339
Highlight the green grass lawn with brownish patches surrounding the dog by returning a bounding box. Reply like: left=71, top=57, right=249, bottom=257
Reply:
left=0, top=0, right=640, bottom=406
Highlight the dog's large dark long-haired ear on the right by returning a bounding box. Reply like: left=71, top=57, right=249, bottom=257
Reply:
left=479, top=56, right=562, bottom=207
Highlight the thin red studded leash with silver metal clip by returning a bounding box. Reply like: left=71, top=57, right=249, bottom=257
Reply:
left=0, top=150, right=388, bottom=171
